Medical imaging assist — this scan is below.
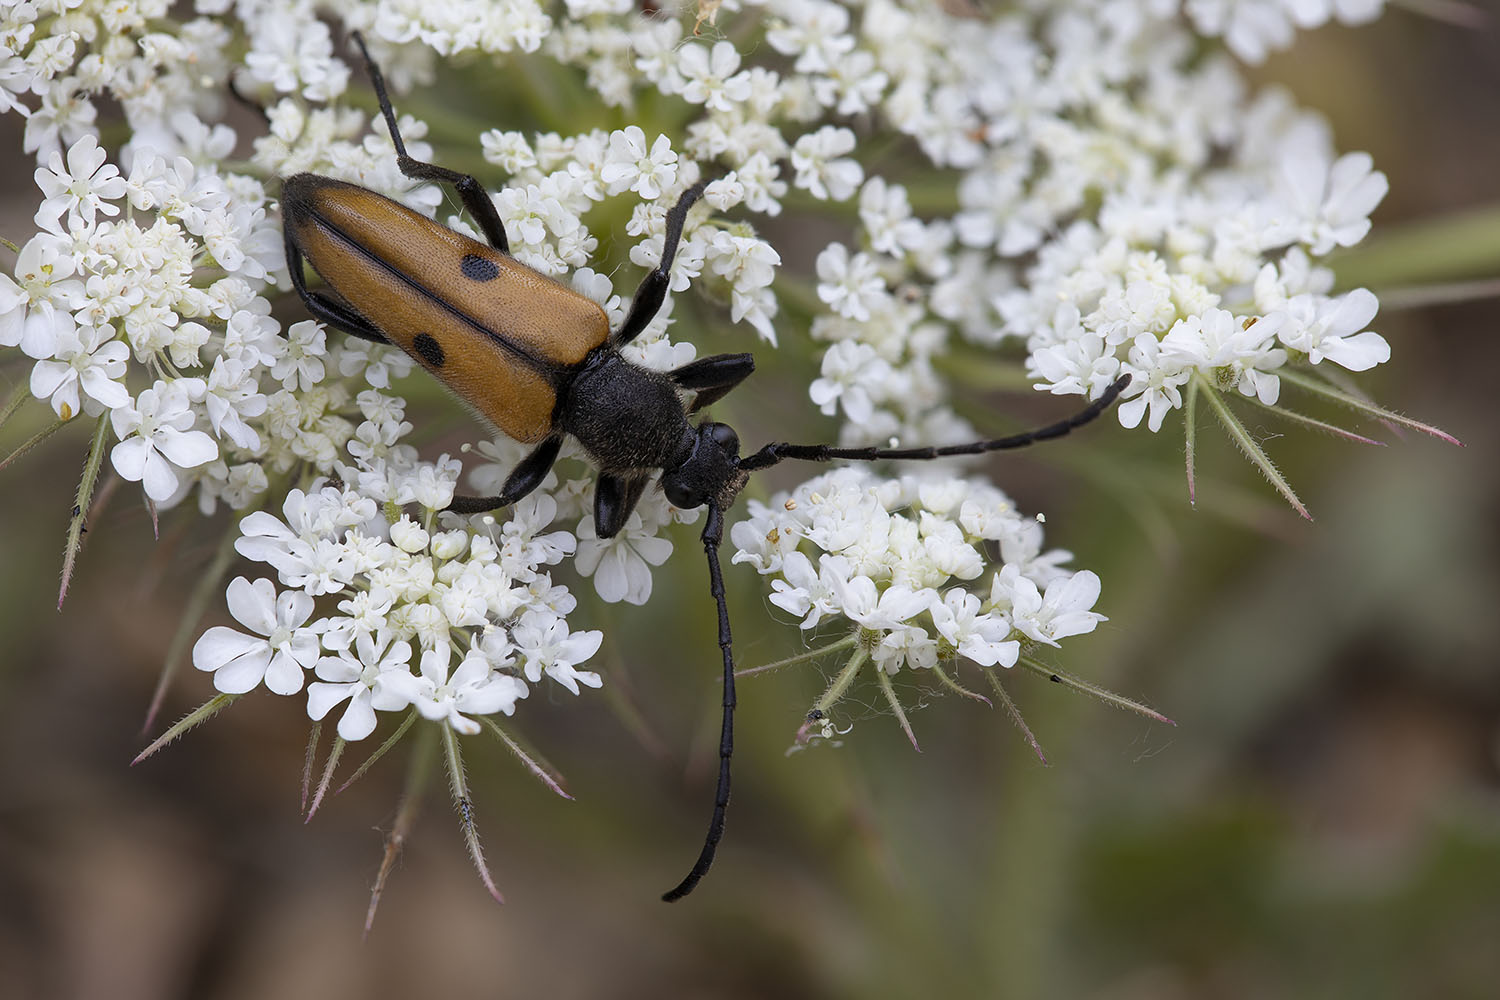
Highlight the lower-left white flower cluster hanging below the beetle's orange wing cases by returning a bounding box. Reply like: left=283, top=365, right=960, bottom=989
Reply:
left=194, top=479, right=603, bottom=741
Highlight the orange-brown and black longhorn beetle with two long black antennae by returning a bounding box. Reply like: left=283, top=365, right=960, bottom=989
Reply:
left=282, top=33, right=1130, bottom=903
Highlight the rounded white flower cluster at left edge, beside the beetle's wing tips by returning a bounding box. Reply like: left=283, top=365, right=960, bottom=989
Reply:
left=0, top=119, right=435, bottom=513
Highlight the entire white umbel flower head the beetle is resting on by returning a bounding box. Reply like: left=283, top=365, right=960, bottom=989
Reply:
left=0, top=0, right=1452, bottom=911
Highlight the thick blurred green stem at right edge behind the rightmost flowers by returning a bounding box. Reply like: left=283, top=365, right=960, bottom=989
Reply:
left=1335, top=204, right=1500, bottom=292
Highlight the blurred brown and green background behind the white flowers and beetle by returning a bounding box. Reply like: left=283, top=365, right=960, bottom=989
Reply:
left=0, top=10, right=1500, bottom=1000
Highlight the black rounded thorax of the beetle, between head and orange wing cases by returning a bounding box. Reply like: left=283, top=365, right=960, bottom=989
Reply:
left=554, top=345, right=692, bottom=472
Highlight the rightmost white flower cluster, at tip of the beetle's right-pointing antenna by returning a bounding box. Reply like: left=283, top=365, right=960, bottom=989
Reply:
left=1014, top=122, right=1391, bottom=430
